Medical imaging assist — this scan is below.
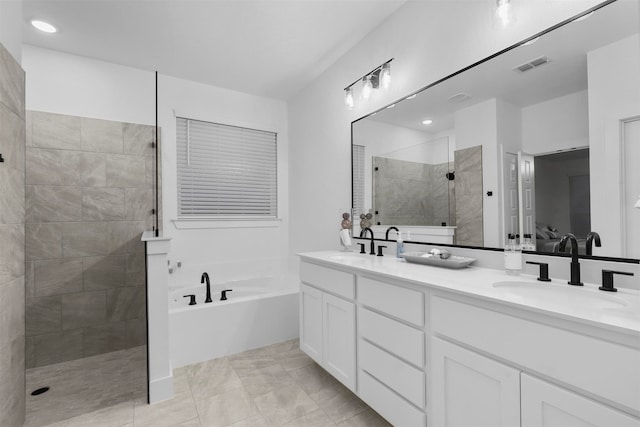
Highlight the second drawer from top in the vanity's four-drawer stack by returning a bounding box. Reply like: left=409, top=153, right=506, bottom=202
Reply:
left=358, top=308, right=424, bottom=367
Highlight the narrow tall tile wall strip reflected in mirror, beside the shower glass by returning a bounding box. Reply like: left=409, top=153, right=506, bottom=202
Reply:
left=454, top=146, right=484, bottom=246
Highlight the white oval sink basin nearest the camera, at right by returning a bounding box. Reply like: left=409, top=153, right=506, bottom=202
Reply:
left=493, top=281, right=629, bottom=309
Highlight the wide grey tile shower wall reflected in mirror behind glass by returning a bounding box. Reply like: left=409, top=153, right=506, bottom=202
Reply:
left=373, top=157, right=451, bottom=225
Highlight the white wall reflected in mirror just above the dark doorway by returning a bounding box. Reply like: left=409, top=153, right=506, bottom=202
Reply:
left=522, top=90, right=589, bottom=155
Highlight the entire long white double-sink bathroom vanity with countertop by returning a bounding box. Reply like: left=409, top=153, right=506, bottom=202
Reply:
left=300, top=252, right=640, bottom=427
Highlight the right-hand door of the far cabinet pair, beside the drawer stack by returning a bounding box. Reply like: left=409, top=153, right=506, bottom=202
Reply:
left=322, top=294, right=356, bottom=390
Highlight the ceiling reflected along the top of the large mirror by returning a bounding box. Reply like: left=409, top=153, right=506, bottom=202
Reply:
left=370, top=0, right=640, bottom=134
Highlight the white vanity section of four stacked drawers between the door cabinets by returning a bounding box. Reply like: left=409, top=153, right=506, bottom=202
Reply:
left=357, top=276, right=426, bottom=426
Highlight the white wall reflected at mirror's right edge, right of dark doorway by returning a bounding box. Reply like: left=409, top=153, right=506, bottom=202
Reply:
left=587, top=34, right=640, bottom=256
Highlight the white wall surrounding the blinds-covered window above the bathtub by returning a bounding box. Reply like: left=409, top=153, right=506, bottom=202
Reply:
left=159, top=76, right=289, bottom=272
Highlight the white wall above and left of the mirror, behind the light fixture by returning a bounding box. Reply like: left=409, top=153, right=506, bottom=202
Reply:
left=289, top=0, right=599, bottom=253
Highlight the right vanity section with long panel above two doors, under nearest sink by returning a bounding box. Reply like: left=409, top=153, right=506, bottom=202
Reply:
left=430, top=296, right=640, bottom=427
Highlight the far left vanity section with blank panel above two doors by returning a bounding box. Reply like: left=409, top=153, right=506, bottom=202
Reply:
left=300, top=262, right=356, bottom=391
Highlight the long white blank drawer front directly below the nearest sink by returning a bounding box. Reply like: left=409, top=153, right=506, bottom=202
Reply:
left=430, top=296, right=640, bottom=412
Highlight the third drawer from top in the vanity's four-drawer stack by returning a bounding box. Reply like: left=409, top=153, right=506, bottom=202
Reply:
left=359, top=340, right=425, bottom=408
